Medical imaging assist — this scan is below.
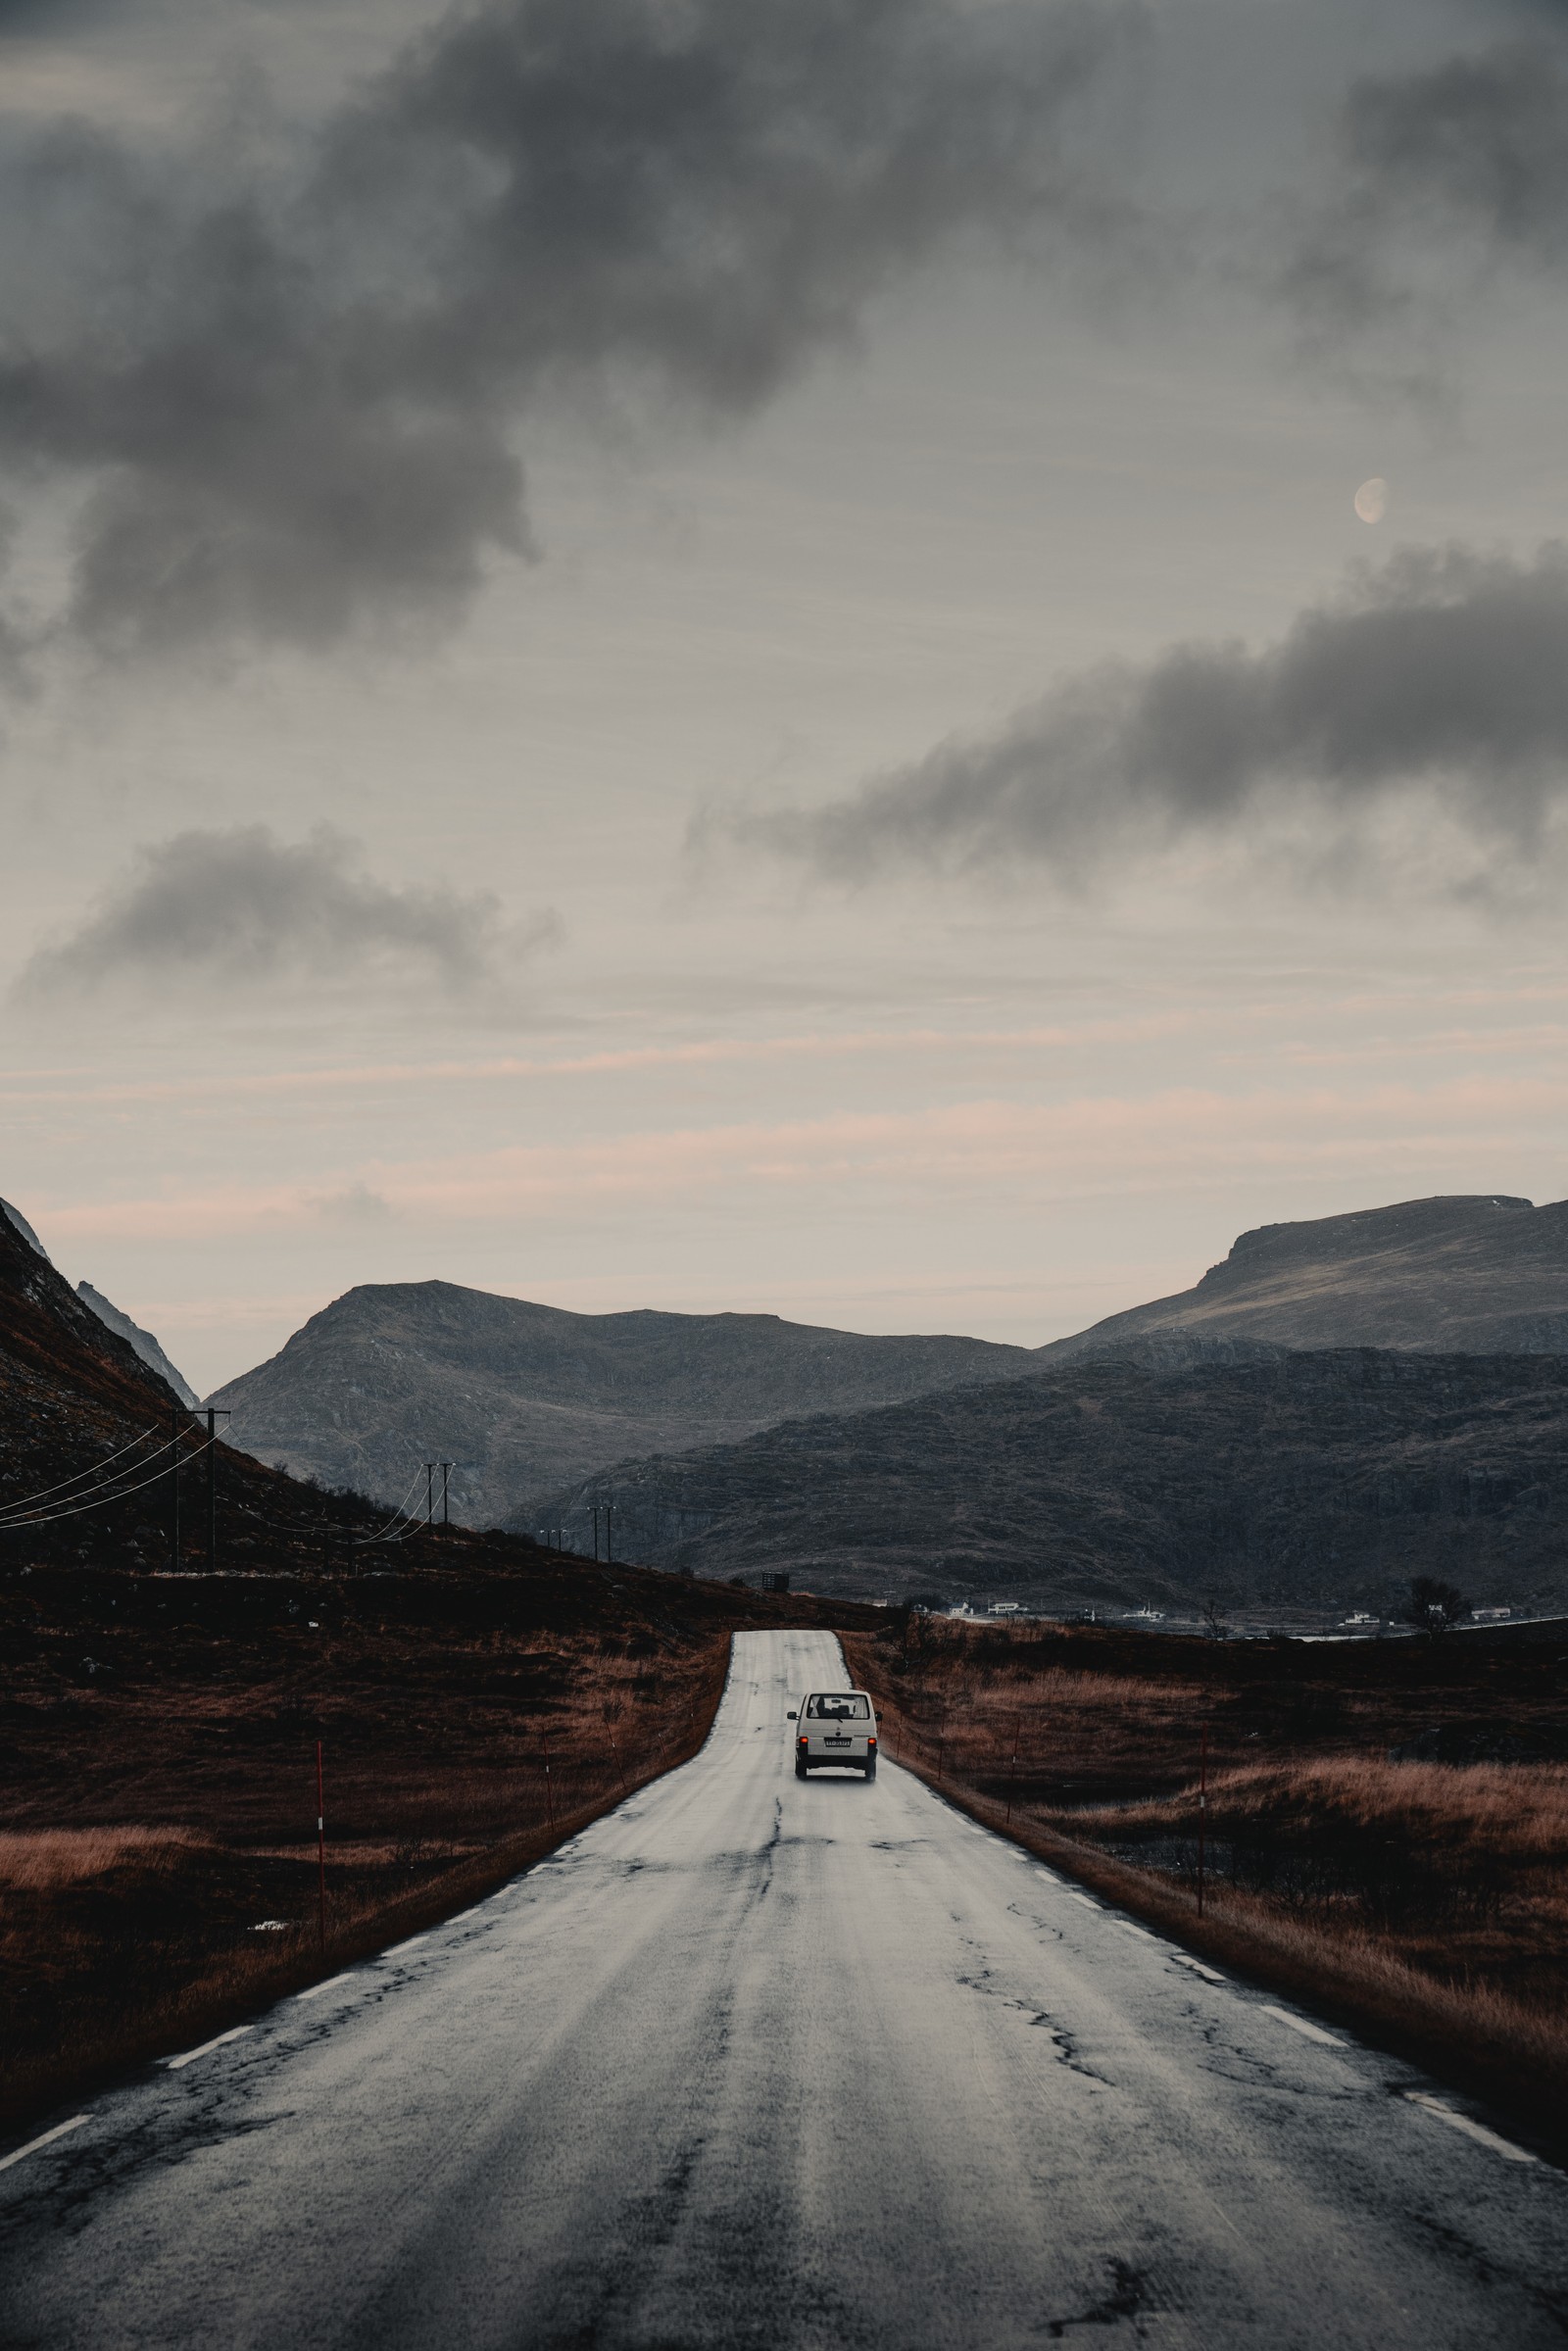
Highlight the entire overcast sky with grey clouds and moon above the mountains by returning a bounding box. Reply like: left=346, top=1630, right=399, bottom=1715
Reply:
left=0, top=0, right=1568, bottom=1390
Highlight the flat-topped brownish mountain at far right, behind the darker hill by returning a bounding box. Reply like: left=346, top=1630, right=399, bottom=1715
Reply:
left=1037, top=1192, right=1568, bottom=1366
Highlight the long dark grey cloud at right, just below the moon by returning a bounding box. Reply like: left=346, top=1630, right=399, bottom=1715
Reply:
left=736, top=543, right=1568, bottom=879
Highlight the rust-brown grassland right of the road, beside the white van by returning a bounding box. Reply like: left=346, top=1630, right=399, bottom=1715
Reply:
left=844, top=1613, right=1568, bottom=2137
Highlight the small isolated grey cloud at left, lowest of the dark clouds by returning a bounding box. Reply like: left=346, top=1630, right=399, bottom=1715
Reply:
left=17, top=825, right=521, bottom=1000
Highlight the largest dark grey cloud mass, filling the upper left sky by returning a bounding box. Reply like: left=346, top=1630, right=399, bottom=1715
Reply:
left=0, top=0, right=1131, bottom=672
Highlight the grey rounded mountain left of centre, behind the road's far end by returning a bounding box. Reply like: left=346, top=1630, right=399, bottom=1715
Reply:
left=212, top=1281, right=1034, bottom=1526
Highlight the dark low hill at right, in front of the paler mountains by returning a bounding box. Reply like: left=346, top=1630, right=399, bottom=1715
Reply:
left=550, top=1347, right=1568, bottom=1610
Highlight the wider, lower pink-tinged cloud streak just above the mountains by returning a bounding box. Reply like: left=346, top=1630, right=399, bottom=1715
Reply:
left=37, top=1077, right=1568, bottom=1242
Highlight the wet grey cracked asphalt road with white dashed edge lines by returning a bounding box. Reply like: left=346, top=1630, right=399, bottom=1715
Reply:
left=0, top=1632, right=1568, bottom=2351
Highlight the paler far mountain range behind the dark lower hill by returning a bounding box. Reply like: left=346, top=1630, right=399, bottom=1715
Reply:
left=212, top=1195, right=1568, bottom=1528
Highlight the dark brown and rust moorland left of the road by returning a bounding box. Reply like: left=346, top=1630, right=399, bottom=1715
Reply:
left=0, top=1538, right=872, bottom=2123
